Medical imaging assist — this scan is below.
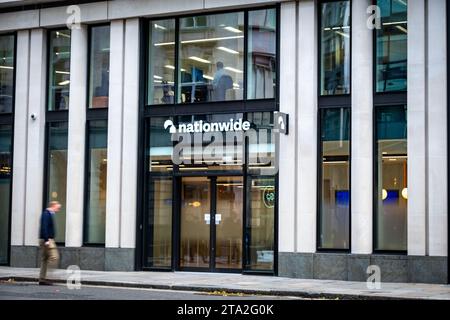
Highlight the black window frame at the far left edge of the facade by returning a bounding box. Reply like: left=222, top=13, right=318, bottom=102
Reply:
left=0, top=31, right=17, bottom=266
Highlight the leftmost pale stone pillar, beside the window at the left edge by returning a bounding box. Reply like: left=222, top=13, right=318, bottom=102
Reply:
left=11, top=30, right=30, bottom=246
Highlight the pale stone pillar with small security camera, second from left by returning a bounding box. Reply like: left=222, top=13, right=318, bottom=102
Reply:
left=23, top=29, right=47, bottom=246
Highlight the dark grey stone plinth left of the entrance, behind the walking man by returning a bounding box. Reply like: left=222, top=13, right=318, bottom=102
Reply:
left=11, top=246, right=135, bottom=271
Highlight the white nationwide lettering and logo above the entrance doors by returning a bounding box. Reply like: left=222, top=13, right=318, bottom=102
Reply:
left=164, top=119, right=250, bottom=133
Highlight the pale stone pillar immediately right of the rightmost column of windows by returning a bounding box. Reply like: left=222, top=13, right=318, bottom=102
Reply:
left=407, top=0, right=427, bottom=256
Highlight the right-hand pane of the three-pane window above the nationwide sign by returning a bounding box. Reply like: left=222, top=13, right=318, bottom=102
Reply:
left=247, top=9, right=277, bottom=99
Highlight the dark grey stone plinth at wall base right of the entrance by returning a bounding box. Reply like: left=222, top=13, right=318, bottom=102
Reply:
left=278, top=252, right=448, bottom=284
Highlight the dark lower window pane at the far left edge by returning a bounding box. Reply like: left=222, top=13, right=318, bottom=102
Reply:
left=0, top=125, right=13, bottom=264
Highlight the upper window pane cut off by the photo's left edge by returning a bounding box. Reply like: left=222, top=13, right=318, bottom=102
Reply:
left=0, top=35, right=14, bottom=113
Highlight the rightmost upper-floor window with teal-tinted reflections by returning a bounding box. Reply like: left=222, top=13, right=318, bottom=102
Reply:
left=376, top=0, right=408, bottom=92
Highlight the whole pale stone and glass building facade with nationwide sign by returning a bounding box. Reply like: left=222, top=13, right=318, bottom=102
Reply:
left=0, top=0, right=449, bottom=283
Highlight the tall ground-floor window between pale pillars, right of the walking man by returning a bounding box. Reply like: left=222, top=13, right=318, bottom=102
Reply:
left=85, top=120, right=108, bottom=244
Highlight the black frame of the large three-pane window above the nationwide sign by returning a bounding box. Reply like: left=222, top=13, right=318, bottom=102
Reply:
left=140, top=4, right=280, bottom=116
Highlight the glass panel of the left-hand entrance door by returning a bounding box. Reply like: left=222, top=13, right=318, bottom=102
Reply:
left=180, top=177, right=211, bottom=268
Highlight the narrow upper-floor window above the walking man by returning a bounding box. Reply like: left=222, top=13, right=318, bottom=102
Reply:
left=48, top=29, right=70, bottom=111
